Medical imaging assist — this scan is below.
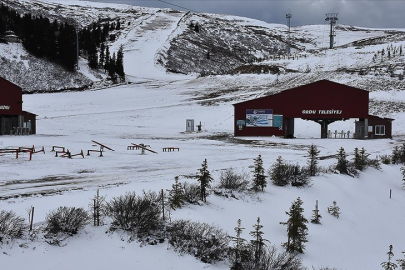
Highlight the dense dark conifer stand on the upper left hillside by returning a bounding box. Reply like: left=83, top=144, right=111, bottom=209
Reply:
left=0, top=3, right=124, bottom=80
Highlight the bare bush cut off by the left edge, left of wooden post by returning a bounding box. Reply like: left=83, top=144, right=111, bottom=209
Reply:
left=0, top=210, right=28, bottom=242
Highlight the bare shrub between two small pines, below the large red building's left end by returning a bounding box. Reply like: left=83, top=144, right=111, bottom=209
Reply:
left=218, top=167, right=249, bottom=191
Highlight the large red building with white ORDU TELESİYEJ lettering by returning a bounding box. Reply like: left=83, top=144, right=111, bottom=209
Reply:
left=234, top=80, right=393, bottom=138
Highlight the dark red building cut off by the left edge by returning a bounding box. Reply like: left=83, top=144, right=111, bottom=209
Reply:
left=0, top=77, right=36, bottom=135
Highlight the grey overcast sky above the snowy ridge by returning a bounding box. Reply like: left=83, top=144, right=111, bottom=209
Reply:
left=91, top=0, right=405, bottom=28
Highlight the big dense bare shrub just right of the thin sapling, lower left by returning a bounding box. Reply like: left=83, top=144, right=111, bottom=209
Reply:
left=107, top=192, right=162, bottom=236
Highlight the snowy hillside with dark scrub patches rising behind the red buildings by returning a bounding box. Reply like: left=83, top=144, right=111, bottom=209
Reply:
left=0, top=0, right=405, bottom=95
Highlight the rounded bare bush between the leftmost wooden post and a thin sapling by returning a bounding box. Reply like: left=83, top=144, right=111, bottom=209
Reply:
left=45, top=206, right=90, bottom=235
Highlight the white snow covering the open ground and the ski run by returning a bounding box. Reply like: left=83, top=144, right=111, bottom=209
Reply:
left=0, top=1, right=405, bottom=270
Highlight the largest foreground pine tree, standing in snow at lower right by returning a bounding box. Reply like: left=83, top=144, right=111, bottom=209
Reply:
left=282, top=197, right=308, bottom=253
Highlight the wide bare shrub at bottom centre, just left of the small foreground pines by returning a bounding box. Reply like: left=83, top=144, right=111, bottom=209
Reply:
left=167, top=220, right=229, bottom=263
